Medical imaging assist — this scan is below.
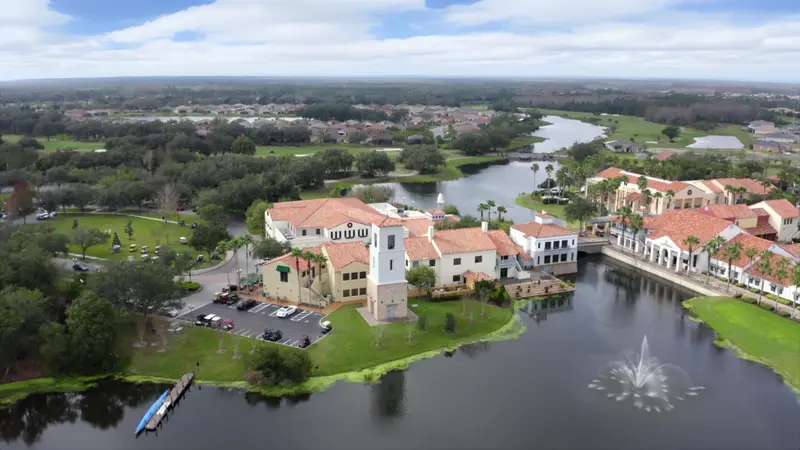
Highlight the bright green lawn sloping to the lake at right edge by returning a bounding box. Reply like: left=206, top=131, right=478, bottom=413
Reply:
left=683, top=297, right=800, bottom=391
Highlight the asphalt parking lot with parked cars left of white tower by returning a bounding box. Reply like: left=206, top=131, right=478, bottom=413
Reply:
left=180, top=303, right=324, bottom=346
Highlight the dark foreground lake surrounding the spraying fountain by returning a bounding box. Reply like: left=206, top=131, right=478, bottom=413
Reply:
left=0, top=257, right=800, bottom=450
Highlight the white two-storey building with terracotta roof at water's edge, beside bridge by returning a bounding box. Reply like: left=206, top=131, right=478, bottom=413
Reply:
left=509, top=211, right=578, bottom=275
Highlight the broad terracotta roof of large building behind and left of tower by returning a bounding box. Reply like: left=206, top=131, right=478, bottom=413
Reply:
left=269, top=198, right=387, bottom=228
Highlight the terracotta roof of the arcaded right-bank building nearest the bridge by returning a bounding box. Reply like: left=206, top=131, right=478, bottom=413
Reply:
left=648, top=209, right=735, bottom=251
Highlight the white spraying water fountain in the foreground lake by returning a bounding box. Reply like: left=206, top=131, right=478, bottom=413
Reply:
left=589, top=336, right=705, bottom=412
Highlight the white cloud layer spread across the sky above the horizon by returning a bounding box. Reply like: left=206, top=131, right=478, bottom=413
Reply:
left=0, top=0, right=800, bottom=81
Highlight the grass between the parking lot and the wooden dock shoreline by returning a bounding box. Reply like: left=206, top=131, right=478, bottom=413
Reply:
left=126, top=326, right=301, bottom=383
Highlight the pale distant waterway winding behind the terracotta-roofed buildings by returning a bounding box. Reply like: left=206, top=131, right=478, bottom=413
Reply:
left=387, top=116, right=604, bottom=223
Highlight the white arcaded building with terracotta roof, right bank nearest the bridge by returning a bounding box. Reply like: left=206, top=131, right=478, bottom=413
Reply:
left=643, top=210, right=744, bottom=273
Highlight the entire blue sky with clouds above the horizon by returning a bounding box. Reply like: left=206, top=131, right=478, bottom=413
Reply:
left=0, top=0, right=800, bottom=83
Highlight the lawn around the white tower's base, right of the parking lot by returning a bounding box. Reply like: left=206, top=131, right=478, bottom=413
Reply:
left=309, top=298, right=512, bottom=376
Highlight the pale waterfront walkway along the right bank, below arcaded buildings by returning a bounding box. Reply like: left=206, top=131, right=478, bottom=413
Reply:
left=603, top=242, right=800, bottom=316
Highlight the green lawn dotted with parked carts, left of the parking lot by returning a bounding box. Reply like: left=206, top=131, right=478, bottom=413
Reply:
left=42, top=214, right=200, bottom=260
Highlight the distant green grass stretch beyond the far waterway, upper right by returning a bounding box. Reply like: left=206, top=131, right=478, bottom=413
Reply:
left=538, top=109, right=752, bottom=148
